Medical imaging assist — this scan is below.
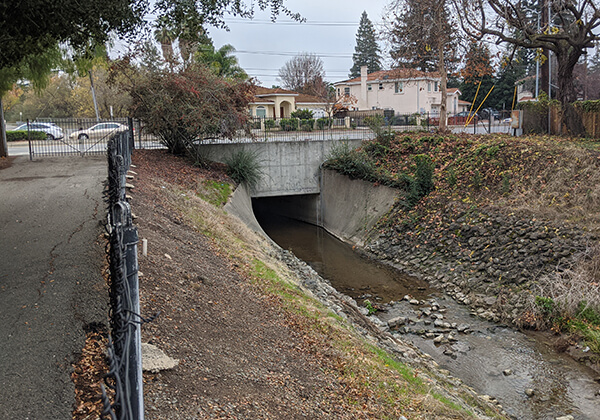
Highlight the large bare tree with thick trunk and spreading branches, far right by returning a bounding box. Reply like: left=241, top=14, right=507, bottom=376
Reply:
left=453, top=0, right=600, bottom=135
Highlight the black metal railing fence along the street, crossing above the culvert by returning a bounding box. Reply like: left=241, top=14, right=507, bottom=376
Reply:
left=11, top=113, right=510, bottom=159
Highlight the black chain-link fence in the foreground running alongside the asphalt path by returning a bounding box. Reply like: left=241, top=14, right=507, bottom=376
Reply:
left=102, top=131, right=144, bottom=420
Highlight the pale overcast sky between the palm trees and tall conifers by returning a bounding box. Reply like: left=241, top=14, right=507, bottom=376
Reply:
left=209, top=0, right=389, bottom=87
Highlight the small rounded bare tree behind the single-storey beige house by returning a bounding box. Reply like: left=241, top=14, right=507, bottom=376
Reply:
left=279, top=53, right=325, bottom=95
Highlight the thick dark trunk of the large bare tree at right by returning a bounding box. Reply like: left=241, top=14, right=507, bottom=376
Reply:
left=556, top=45, right=585, bottom=136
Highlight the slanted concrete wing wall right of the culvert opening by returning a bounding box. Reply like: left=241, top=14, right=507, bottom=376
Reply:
left=321, top=170, right=399, bottom=245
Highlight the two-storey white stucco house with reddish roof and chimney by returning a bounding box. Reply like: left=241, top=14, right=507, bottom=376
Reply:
left=334, top=66, right=470, bottom=116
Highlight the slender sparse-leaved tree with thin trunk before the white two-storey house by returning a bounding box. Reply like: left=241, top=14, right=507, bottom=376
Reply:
left=388, top=0, right=456, bottom=130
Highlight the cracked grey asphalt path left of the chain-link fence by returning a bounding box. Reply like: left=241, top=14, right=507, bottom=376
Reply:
left=0, top=156, right=108, bottom=419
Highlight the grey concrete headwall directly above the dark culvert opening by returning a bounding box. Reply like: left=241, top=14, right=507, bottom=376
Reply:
left=200, top=140, right=361, bottom=197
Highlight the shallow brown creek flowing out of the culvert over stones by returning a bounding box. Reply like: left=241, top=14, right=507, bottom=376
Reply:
left=254, top=206, right=600, bottom=420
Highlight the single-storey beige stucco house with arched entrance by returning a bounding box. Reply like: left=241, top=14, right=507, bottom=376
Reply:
left=248, top=86, right=327, bottom=119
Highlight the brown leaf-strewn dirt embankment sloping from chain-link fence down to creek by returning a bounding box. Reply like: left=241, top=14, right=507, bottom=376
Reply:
left=127, top=151, right=502, bottom=419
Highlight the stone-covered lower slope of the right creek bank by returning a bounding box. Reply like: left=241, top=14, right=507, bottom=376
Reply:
left=365, top=205, right=598, bottom=334
